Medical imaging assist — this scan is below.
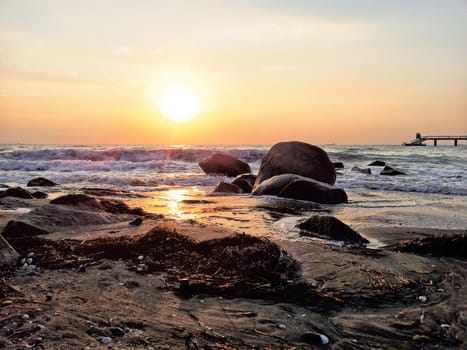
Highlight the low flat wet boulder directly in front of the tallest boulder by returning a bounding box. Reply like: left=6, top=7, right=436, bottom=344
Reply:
left=252, top=174, right=347, bottom=204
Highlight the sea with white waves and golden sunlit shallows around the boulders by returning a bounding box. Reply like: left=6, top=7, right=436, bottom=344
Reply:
left=0, top=144, right=467, bottom=239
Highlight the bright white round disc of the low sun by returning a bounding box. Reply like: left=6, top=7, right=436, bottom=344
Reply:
left=159, top=86, right=201, bottom=123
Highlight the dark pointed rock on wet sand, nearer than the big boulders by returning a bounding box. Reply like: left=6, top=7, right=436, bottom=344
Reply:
left=297, top=215, right=369, bottom=244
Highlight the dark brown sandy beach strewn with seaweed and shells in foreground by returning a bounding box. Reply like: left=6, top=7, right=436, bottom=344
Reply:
left=0, top=191, right=467, bottom=349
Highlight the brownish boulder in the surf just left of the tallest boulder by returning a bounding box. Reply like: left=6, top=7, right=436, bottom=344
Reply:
left=199, top=153, right=251, bottom=177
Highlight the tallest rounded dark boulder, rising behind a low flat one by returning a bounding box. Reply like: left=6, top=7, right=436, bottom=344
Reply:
left=255, top=141, right=336, bottom=187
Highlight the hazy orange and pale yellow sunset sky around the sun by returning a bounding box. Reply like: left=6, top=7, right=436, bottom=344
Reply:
left=0, top=0, right=467, bottom=144
